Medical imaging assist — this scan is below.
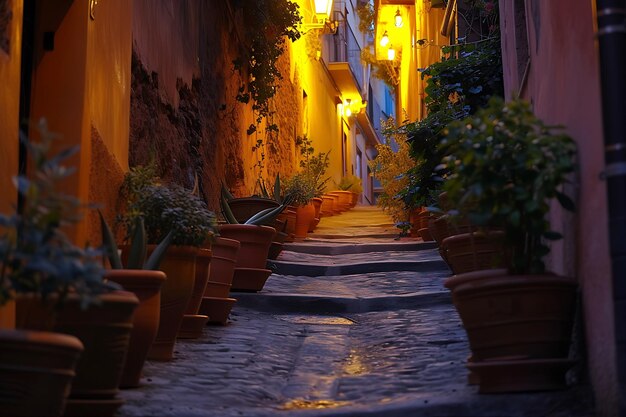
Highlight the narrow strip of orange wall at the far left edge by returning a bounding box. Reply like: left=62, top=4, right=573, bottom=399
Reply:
left=0, top=0, right=23, bottom=328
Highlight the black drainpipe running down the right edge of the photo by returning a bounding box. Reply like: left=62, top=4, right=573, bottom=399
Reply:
left=596, top=0, right=626, bottom=406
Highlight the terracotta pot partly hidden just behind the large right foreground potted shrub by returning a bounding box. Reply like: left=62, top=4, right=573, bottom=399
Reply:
left=441, top=231, right=506, bottom=274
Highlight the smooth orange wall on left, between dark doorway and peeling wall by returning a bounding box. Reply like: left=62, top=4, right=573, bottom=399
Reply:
left=32, top=0, right=132, bottom=244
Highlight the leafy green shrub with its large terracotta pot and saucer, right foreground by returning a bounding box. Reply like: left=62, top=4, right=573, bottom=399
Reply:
left=444, top=99, right=577, bottom=392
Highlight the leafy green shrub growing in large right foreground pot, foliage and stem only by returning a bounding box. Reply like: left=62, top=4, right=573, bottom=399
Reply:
left=443, top=98, right=576, bottom=273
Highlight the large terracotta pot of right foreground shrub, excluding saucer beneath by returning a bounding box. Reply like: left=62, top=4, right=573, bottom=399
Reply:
left=445, top=269, right=577, bottom=360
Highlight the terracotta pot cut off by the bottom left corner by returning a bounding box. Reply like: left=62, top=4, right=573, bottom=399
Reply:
left=0, top=330, right=83, bottom=416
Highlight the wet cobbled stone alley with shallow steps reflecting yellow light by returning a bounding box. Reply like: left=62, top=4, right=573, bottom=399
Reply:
left=118, top=207, right=594, bottom=417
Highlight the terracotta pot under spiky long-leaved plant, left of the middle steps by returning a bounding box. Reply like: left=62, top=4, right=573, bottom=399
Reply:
left=220, top=224, right=276, bottom=268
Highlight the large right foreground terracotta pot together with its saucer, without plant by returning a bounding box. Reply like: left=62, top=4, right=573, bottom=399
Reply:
left=445, top=269, right=577, bottom=393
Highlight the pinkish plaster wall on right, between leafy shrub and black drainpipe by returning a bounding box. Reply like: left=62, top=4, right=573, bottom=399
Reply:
left=500, top=0, right=618, bottom=415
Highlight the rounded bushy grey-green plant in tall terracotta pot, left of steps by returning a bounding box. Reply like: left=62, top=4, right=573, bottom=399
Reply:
left=120, top=167, right=216, bottom=360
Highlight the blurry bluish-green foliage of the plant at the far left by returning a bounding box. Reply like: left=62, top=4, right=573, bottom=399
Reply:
left=0, top=121, right=114, bottom=308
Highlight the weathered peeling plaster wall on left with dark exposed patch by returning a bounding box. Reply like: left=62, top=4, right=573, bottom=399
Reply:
left=129, top=0, right=302, bottom=209
